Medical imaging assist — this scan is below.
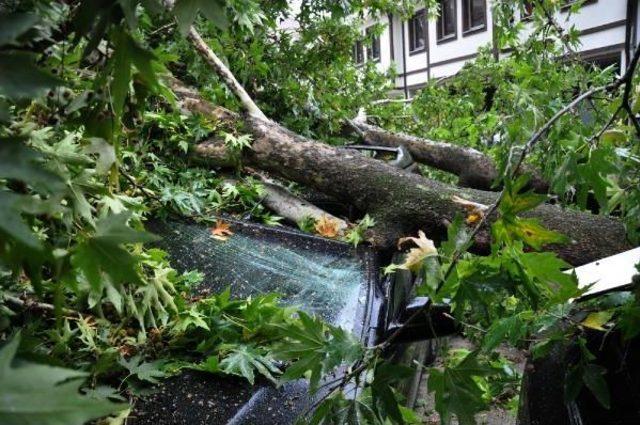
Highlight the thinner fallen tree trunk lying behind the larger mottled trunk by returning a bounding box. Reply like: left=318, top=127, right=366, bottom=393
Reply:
left=350, top=120, right=549, bottom=193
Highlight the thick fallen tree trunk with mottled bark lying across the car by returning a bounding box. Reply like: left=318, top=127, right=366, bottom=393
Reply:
left=194, top=109, right=630, bottom=265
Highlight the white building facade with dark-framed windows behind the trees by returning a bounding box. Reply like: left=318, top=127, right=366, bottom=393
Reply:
left=354, top=0, right=638, bottom=97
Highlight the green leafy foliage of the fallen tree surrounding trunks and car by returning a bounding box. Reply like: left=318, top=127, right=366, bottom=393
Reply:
left=0, top=0, right=640, bottom=425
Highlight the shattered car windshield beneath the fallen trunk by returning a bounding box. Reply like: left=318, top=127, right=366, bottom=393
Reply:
left=149, top=221, right=367, bottom=327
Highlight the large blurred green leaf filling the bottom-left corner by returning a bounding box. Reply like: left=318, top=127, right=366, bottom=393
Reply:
left=0, top=336, right=127, bottom=425
